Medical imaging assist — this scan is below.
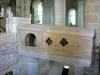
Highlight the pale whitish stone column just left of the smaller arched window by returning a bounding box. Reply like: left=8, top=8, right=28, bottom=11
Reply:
left=55, top=0, right=66, bottom=25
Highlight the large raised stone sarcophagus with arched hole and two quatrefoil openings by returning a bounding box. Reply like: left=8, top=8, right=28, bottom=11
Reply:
left=18, top=25, right=95, bottom=66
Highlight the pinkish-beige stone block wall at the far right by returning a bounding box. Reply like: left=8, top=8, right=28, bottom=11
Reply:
left=85, top=0, right=100, bottom=44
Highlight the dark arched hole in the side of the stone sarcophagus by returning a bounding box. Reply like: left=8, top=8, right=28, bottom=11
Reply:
left=25, top=33, right=36, bottom=47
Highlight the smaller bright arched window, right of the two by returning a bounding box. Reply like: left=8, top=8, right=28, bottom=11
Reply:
left=68, top=8, right=76, bottom=26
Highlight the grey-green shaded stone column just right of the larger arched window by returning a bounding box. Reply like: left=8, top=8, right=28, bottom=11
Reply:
left=42, top=0, right=55, bottom=25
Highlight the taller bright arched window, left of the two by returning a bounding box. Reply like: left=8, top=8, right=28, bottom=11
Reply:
left=31, top=1, right=43, bottom=24
